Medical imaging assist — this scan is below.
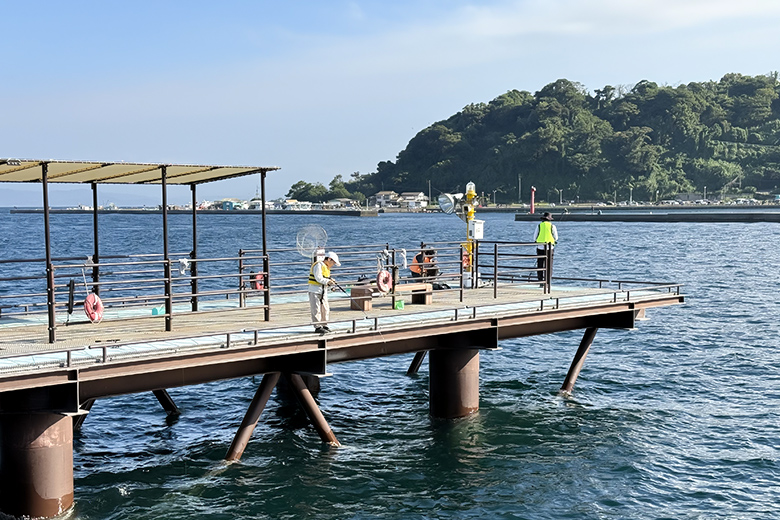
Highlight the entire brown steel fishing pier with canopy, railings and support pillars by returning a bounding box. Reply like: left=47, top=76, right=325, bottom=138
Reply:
left=0, top=160, right=684, bottom=517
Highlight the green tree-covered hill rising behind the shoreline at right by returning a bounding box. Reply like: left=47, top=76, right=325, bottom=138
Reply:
left=346, top=72, right=780, bottom=203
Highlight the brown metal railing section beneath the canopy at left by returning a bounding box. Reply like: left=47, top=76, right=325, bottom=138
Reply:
left=0, top=252, right=269, bottom=343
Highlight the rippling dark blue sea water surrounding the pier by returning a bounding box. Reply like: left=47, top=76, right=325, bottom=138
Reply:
left=0, top=210, right=780, bottom=520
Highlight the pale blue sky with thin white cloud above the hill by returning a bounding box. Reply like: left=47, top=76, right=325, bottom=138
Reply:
left=0, top=0, right=780, bottom=206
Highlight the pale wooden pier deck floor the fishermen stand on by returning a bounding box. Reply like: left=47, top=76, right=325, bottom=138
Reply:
left=0, top=284, right=683, bottom=390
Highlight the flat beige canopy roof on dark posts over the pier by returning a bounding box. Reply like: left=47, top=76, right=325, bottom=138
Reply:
left=0, top=159, right=279, bottom=185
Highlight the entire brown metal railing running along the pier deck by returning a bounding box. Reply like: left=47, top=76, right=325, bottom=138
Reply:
left=0, top=240, right=679, bottom=342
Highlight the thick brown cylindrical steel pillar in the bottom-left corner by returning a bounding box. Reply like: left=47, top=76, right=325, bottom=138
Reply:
left=0, top=412, right=73, bottom=518
